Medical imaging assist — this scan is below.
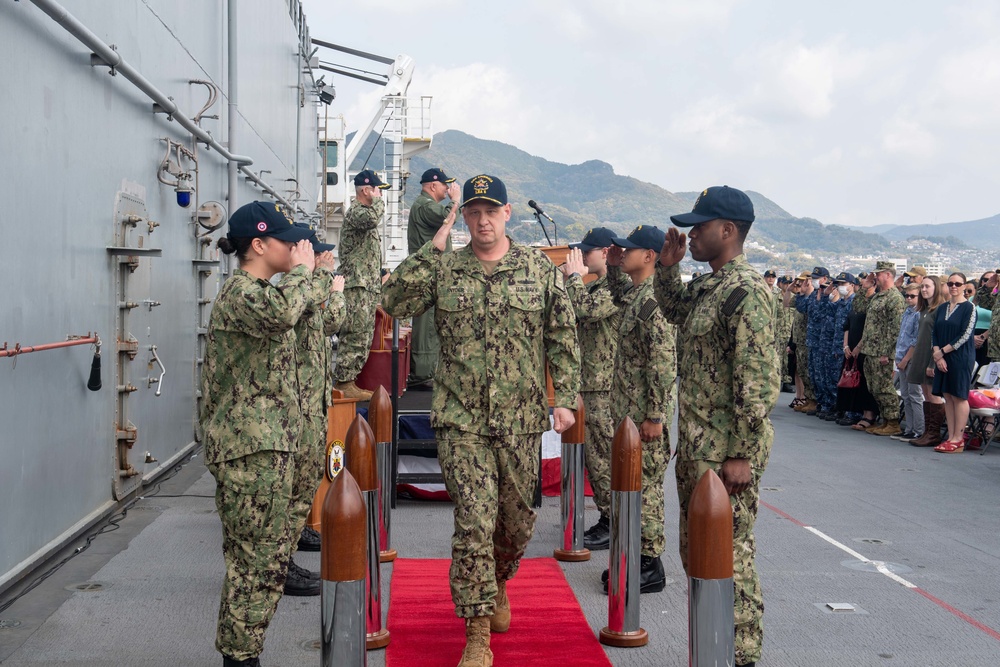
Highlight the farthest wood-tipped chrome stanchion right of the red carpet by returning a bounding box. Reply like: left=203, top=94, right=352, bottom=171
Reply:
left=552, top=396, right=590, bottom=562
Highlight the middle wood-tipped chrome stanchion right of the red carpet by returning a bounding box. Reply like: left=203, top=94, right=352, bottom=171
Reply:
left=600, top=417, right=649, bottom=648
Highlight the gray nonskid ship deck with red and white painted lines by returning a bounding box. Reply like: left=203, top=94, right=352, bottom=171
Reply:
left=0, top=394, right=1000, bottom=667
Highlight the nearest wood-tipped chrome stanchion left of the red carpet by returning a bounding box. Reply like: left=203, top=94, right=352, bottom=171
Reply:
left=320, top=464, right=368, bottom=667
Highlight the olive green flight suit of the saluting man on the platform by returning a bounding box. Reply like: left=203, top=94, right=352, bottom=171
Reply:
left=406, top=192, right=455, bottom=382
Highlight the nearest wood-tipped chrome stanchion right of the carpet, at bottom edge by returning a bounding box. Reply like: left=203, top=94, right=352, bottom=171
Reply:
left=688, top=470, right=735, bottom=667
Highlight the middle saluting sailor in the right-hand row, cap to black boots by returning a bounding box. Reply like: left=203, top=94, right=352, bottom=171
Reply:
left=602, top=225, right=676, bottom=593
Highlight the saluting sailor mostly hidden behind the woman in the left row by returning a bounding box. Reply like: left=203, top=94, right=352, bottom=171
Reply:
left=285, top=222, right=344, bottom=560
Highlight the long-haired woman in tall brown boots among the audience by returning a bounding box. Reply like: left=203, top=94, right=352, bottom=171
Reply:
left=906, top=276, right=947, bottom=447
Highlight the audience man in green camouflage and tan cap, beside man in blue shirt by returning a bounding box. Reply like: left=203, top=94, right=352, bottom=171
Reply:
left=859, top=260, right=906, bottom=435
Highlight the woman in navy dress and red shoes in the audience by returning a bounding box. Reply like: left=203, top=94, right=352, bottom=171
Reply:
left=931, top=273, right=976, bottom=454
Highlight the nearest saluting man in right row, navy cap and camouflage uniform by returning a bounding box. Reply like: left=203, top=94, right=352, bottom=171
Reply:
left=655, top=186, right=780, bottom=667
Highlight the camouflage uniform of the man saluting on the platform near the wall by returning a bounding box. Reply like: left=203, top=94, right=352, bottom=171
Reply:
left=336, top=197, right=385, bottom=382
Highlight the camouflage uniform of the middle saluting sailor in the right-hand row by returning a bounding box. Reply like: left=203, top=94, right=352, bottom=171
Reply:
left=608, top=266, right=677, bottom=557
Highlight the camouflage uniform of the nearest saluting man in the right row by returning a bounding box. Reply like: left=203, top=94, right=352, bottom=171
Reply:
left=655, top=255, right=780, bottom=664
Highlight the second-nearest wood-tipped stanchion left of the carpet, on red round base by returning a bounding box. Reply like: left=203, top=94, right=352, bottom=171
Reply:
left=346, top=415, right=389, bottom=650
